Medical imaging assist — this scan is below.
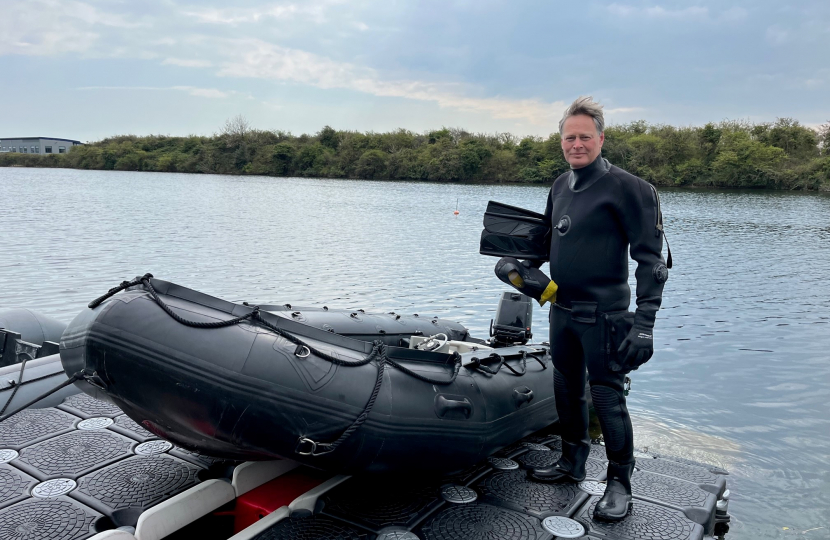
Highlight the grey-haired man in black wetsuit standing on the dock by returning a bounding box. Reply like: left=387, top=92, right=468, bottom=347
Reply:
left=525, top=97, right=671, bottom=521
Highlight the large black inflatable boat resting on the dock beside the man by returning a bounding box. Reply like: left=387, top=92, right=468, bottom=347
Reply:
left=60, top=276, right=557, bottom=472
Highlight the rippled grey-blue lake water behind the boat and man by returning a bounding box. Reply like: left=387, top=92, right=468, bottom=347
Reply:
left=0, top=169, right=830, bottom=539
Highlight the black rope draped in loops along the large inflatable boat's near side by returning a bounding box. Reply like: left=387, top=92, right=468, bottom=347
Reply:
left=89, top=273, right=468, bottom=456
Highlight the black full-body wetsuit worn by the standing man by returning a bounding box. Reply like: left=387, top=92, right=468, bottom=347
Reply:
left=545, top=156, right=668, bottom=463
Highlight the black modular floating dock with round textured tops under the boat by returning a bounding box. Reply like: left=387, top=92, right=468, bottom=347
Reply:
left=0, top=394, right=729, bottom=540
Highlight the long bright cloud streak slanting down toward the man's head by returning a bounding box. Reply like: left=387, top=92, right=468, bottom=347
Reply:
left=213, top=39, right=565, bottom=124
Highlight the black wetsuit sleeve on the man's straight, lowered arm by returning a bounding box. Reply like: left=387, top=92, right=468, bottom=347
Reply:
left=620, top=177, right=668, bottom=328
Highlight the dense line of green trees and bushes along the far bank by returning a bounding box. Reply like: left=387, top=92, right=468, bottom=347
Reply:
left=0, top=117, right=830, bottom=190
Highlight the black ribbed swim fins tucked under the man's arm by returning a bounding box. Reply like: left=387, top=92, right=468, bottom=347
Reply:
left=479, top=201, right=551, bottom=261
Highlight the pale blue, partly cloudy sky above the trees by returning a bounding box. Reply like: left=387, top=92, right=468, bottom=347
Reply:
left=0, top=0, right=830, bottom=142
